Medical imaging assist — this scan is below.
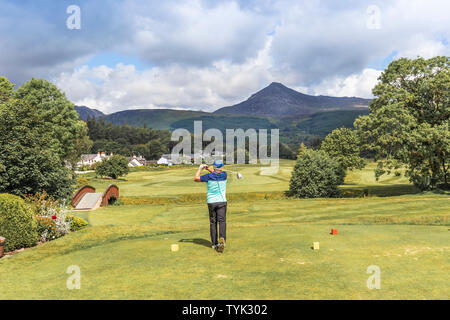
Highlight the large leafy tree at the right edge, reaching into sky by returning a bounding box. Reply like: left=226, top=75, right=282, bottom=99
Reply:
left=355, top=57, right=450, bottom=190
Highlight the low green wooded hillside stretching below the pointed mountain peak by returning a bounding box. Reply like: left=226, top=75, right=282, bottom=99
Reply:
left=76, top=105, right=368, bottom=149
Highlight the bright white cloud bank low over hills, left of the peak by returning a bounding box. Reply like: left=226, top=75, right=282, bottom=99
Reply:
left=54, top=39, right=273, bottom=113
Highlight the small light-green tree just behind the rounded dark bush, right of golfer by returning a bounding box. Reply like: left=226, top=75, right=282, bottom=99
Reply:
left=320, top=128, right=365, bottom=171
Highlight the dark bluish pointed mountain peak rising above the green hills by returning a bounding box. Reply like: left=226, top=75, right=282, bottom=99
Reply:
left=214, top=82, right=371, bottom=118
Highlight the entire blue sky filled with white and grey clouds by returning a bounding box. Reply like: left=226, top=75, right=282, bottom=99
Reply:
left=0, top=0, right=450, bottom=113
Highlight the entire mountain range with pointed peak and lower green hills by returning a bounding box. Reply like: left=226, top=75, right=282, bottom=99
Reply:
left=75, top=82, right=371, bottom=144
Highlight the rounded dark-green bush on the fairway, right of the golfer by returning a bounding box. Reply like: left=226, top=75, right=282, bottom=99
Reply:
left=289, top=149, right=342, bottom=198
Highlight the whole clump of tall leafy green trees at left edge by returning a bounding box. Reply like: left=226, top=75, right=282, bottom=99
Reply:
left=0, top=79, right=89, bottom=199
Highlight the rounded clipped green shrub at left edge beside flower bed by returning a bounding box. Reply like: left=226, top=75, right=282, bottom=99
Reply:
left=0, top=193, right=38, bottom=252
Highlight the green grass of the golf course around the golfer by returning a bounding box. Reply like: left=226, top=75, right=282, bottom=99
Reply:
left=0, top=160, right=450, bottom=299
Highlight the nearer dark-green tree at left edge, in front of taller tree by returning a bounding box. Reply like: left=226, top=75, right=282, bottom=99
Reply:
left=0, top=100, right=73, bottom=199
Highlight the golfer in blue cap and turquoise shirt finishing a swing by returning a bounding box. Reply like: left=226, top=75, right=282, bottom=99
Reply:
left=194, top=160, right=227, bottom=252
